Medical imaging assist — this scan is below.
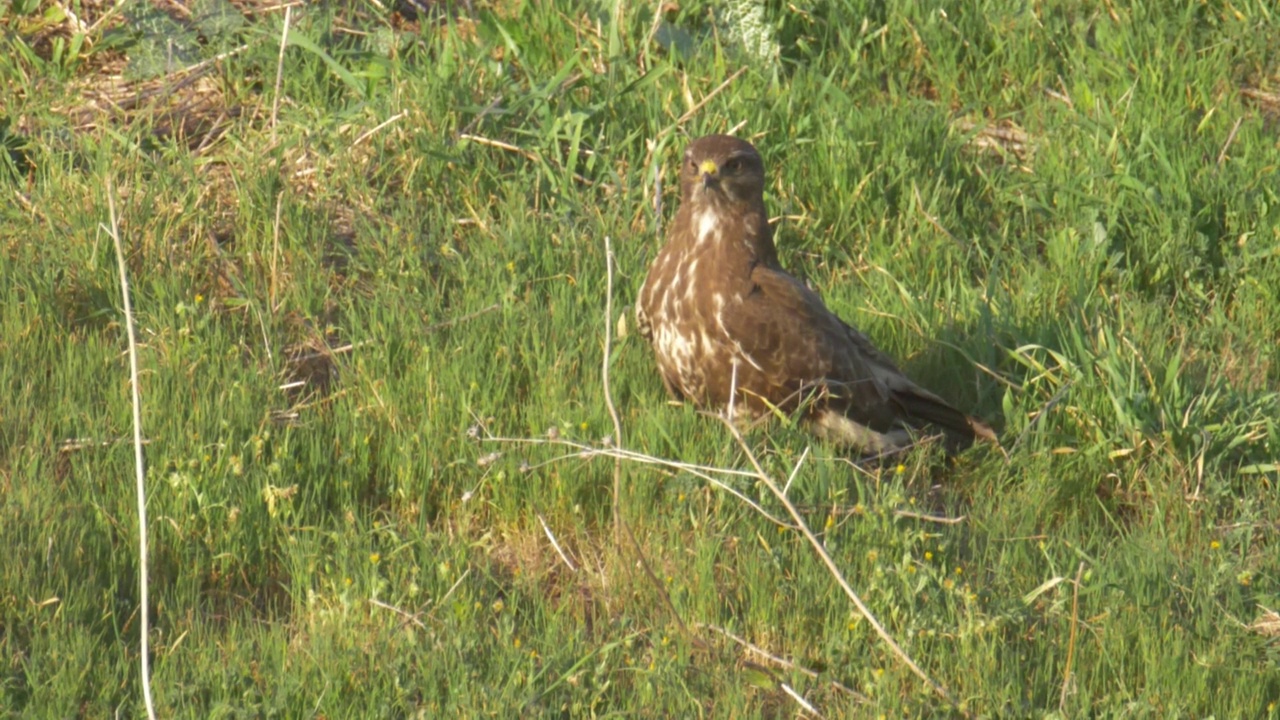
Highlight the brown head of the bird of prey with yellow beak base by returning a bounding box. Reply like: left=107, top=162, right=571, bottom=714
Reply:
left=680, top=135, right=764, bottom=206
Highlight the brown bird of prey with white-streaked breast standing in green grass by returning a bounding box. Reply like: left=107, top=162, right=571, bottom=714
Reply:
left=636, top=135, right=996, bottom=455
